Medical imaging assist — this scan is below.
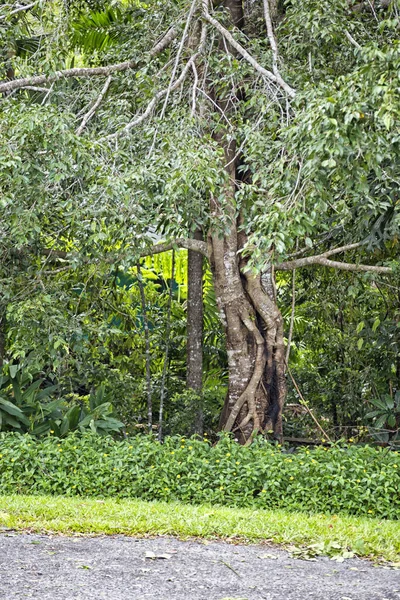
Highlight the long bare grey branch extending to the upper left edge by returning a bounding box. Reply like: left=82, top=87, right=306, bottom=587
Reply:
left=0, top=29, right=176, bottom=93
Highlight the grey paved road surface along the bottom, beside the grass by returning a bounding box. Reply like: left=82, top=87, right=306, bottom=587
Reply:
left=0, top=533, right=400, bottom=600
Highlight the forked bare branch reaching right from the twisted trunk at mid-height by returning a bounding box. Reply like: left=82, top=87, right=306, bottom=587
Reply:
left=275, top=242, right=393, bottom=275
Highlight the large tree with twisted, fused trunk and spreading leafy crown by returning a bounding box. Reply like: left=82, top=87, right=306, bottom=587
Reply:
left=0, top=0, right=400, bottom=442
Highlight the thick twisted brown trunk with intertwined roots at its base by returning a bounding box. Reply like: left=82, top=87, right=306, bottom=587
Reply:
left=209, top=0, right=286, bottom=444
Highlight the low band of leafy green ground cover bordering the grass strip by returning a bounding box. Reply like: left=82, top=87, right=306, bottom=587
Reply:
left=0, top=433, right=400, bottom=519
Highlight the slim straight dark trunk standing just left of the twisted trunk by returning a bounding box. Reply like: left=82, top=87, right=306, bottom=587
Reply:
left=186, top=230, right=203, bottom=435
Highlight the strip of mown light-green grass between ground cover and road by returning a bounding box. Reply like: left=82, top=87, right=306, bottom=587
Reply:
left=0, top=495, right=400, bottom=562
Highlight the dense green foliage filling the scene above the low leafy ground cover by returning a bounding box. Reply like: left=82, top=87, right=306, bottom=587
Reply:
left=0, top=0, right=400, bottom=443
